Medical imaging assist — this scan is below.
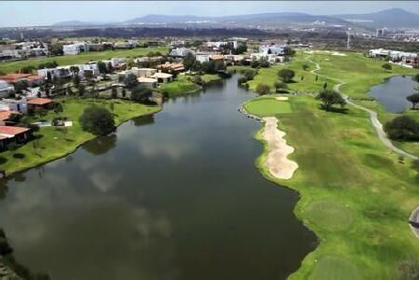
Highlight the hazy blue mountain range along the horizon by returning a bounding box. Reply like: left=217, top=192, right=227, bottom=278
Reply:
left=53, top=8, right=419, bottom=28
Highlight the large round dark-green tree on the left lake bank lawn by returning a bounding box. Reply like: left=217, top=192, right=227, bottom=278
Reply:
left=79, top=106, right=115, bottom=136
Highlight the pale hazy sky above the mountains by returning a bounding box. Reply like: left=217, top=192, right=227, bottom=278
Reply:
left=0, top=1, right=419, bottom=27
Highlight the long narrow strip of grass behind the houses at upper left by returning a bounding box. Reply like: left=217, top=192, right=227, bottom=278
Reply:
left=0, top=47, right=169, bottom=73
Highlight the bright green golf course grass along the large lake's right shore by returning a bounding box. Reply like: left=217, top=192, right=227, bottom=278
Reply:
left=244, top=51, right=419, bottom=279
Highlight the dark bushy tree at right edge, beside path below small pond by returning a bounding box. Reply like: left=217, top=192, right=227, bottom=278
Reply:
left=384, top=115, right=419, bottom=141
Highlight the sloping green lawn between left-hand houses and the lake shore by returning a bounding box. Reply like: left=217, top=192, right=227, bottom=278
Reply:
left=0, top=98, right=160, bottom=174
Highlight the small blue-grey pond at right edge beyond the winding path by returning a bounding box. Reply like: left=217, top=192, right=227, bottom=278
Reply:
left=368, top=76, right=419, bottom=113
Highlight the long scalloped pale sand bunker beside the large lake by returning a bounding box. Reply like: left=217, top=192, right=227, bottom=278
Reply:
left=262, top=117, right=298, bottom=180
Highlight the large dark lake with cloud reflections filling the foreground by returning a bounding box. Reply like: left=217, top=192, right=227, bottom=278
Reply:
left=0, top=77, right=317, bottom=279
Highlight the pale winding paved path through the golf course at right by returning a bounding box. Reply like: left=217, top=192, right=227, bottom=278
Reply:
left=307, top=59, right=419, bottom=160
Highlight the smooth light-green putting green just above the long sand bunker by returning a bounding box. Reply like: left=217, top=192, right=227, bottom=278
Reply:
left=244, top=95, right=291, bottom=117
